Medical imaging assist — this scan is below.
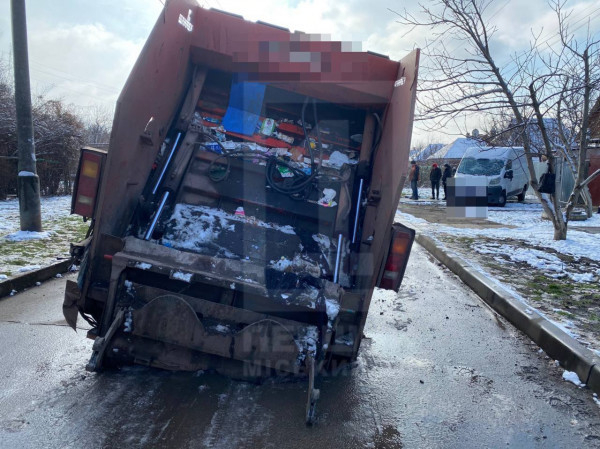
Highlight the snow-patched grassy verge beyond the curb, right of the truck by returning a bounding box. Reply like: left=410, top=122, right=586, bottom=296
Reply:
left=396, top=189, right=600, bottom=354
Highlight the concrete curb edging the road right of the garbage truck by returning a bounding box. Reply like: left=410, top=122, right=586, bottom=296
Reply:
left=416, top=234, right=600, bottom=394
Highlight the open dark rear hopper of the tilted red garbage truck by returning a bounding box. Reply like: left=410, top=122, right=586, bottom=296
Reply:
left=90, top=66, right=383, bottom=375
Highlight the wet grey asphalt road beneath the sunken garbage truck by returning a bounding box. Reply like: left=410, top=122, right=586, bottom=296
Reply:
left=0, top=245, right=600, bottom=449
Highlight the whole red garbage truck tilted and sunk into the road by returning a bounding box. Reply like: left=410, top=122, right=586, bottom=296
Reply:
left=63, top=0, right=419, bottom=423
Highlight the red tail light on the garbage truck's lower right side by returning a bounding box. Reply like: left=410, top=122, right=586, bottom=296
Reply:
left=378, top=223, right=415, bottom=291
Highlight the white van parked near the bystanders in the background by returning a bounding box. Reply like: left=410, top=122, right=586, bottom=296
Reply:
left=456, top=147, right=529, bottom=207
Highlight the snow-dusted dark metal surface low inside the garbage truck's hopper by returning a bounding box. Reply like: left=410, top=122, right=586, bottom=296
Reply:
left=156, top=204, right=340, bottom=321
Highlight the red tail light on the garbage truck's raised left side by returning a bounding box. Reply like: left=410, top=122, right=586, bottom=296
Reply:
left=71, top=148, right=106, bottom=218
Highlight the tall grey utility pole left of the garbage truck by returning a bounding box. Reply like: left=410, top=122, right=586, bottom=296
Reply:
left=10, top=0, right=42, bottom=232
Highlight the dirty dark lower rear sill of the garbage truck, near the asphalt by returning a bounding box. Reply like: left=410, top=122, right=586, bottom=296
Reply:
left=84, top=237, right=343, bottom=375
